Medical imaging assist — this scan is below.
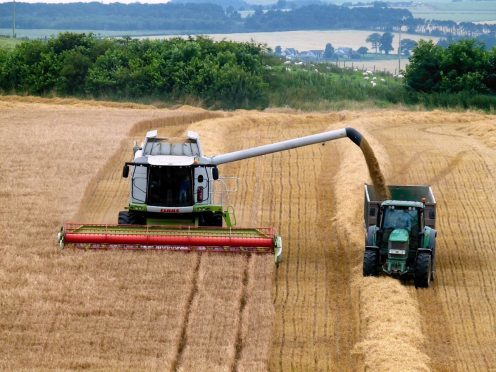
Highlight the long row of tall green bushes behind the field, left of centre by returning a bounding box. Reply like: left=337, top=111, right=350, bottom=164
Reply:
left=0, top=33, right=267, bottom=108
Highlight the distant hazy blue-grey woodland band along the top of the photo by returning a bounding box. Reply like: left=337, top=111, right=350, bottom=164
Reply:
left=0, top=2, right=412, bottom=33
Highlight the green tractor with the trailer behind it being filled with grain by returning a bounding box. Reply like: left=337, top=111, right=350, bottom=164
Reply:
left=363, top=185, right=437, bottom=287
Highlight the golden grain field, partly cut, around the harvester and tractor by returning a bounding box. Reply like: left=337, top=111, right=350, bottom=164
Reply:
left=0, top=99, right=496, bottom=371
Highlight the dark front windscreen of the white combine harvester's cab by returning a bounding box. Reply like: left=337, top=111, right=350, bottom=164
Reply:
left=147, top=166, right=193, bottom=207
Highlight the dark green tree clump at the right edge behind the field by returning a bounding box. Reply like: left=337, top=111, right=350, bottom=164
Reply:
left=405, top=39, right=496, bottom=94
